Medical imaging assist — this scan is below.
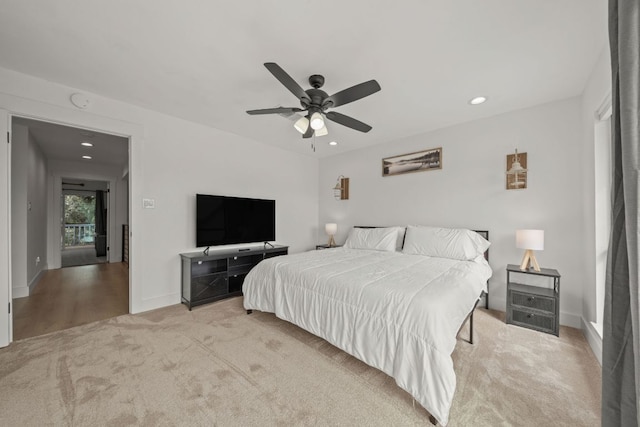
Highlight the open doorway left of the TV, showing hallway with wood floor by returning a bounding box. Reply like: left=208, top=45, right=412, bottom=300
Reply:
left=11, top=117, right=129, bottom=340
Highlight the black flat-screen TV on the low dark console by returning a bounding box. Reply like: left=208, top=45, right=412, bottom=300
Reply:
left=196, top=194, right=276, bottom=247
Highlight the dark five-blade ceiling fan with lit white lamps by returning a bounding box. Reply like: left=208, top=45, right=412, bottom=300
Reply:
left=247, top=62, right=380, bottom=138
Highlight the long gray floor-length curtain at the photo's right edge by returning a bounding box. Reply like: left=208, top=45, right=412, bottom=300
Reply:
left=602, top=0, right=640, bottom=426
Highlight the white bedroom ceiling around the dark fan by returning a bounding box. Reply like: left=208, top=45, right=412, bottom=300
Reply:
left=0, top=0, right=607, bottom=157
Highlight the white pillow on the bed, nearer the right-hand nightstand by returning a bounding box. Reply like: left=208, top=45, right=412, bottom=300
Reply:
left=402, top=226, right=491, bottom=261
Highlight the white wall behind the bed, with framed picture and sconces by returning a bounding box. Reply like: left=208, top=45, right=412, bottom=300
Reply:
left=317, top=98, right=585, bottom=327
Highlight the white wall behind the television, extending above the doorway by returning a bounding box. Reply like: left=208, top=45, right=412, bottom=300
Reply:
left=0, top=69, right=318, bottom=313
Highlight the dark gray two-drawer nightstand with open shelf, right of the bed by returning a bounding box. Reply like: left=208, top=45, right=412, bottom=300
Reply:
left=507, top=264, right=560, bottom=336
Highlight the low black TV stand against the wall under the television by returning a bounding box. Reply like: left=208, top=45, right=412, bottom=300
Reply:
left=180, top=245, right=289, bottom=310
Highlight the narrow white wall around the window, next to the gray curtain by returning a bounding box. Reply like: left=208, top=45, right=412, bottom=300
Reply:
left=580, top=48, right=611, bottom=366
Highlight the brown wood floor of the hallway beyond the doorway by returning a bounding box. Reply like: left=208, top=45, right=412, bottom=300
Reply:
left=13, top=263, right=129, bottom=341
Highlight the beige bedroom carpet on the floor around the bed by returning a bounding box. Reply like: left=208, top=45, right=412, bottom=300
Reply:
left=0, top=298, right=601, bottom=426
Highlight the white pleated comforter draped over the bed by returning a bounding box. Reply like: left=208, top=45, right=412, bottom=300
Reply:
left=242, top=248, right=491, bottom=425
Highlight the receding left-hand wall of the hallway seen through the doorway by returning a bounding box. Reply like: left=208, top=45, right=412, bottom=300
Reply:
left=26, top=133, right=47, bottom=291
